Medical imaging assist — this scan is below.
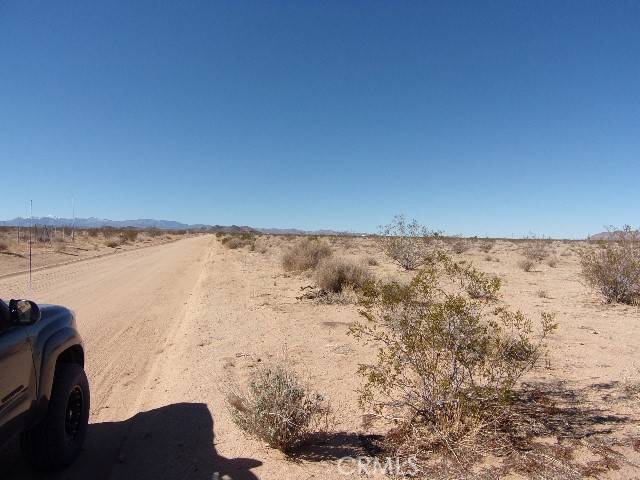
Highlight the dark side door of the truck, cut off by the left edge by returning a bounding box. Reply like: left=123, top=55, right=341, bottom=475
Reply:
left=0, top=326, right=35, bottom=444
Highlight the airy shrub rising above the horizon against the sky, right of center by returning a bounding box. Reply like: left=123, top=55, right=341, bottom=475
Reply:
left=377, top=215, right=439, bottom=270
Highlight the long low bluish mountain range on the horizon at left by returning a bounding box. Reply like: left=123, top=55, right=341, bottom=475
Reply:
left=0, top=217, right=354, bottom=235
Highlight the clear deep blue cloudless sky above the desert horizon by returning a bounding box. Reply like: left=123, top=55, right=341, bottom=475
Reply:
left=0, top=0, right=640, bottom=237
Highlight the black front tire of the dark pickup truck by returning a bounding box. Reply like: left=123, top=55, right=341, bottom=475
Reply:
left=20, top=363, right=90, bottom=471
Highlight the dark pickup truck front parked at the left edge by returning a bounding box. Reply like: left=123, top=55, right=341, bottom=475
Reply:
left=0, top=300, right=90, bottom=471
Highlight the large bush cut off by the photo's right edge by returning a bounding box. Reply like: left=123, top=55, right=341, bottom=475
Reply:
left=580, top=226, right=640, bottom=304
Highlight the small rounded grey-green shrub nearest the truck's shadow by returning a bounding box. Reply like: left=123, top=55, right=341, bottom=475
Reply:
left=227, top=365, right=329, bottom=453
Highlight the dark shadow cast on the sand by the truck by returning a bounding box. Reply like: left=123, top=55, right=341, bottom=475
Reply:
left=0, top=403, right=262, bottom=480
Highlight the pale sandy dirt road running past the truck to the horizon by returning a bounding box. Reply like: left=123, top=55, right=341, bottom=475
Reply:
left=0, top=236, right=258, bottom=479
